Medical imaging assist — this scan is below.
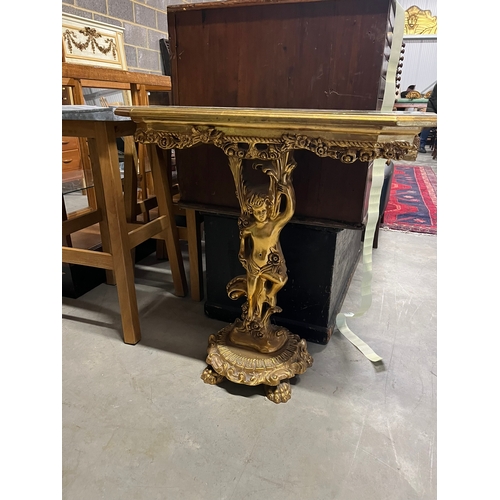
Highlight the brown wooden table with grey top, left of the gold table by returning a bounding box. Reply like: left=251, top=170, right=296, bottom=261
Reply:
left=62, top=106, right=187, bottom=344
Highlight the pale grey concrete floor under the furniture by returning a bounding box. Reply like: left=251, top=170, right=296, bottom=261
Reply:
left=62, top=154, right=437, bottom=500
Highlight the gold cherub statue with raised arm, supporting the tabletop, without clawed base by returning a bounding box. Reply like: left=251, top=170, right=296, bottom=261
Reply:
left=227, top=154, right=295, bottom=353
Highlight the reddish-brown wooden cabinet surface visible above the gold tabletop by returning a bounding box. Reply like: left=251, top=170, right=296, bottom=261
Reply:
left=169, top=0, right=389, bottom=109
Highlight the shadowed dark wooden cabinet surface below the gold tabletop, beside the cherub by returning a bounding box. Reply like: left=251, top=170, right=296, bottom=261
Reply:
left=176, top=146, right=371, bottom=228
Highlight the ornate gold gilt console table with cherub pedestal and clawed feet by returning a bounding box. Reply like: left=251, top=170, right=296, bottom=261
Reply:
left=115, top=106, right=437, bottom=403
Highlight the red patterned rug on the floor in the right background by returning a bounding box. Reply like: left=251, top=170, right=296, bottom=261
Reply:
left=381, top=165, right=437, bottom=234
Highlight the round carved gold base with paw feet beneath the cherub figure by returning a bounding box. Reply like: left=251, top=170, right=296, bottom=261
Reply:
left=201, top=325, right=313, bottom=403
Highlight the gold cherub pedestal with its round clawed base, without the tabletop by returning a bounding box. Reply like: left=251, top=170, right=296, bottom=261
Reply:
left=202, top=150, right=313, bottom=403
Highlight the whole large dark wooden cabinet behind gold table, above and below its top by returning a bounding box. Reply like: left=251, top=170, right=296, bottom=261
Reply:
left=168, top=0, right=395, bottom=228
